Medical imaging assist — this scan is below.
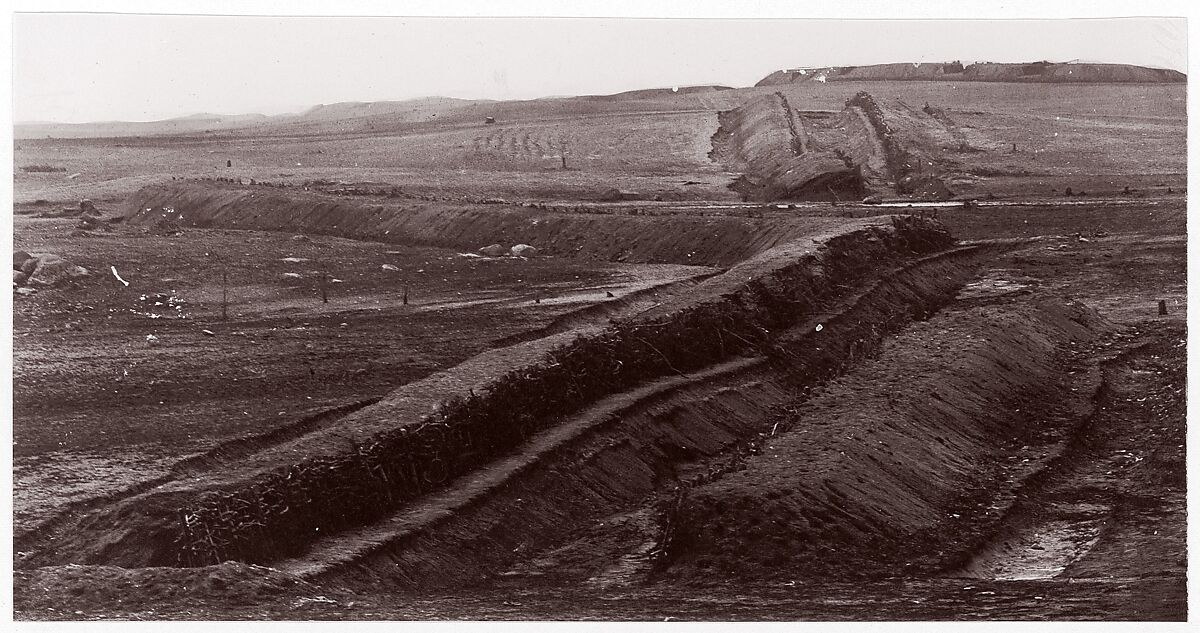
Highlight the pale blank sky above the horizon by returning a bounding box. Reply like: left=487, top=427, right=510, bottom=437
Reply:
left=13, top=13, right=1187, bottom=122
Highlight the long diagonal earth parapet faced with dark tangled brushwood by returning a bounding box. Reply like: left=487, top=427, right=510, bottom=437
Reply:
left=18, top=218, right=949, bottom=566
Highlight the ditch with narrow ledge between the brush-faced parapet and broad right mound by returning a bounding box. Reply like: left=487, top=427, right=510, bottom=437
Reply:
left=304, top=248, right=979, bottom=589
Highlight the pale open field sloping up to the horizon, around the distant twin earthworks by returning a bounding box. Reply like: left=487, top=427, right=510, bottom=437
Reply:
left=14, top=82, right=1186, bottom=203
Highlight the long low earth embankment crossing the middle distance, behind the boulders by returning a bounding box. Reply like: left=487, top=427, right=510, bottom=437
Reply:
left=125, top=182, right=864, bottom=266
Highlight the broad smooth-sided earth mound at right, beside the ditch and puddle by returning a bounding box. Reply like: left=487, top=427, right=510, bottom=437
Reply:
left=667, top=302, right=1110, bottom=579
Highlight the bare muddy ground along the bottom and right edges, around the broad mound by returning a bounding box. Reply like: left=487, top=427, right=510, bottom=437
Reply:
left=11, top=196, right=1186, bottom=620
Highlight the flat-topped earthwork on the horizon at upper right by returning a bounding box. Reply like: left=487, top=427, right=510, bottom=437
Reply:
left=755, top=61, right=1188, bottom=86
